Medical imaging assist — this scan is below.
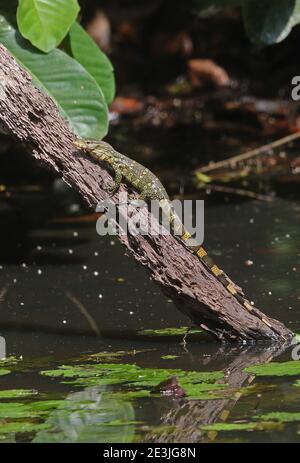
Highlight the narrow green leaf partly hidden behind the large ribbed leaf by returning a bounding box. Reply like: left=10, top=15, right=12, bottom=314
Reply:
left=69, top=22, right=115, bottom=104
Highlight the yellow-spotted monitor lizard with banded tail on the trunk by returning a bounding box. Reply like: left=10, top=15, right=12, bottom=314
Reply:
left=74, top=138, right=283, bottom=337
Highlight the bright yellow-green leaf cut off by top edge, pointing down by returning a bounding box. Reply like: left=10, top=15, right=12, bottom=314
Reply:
left=17, top=0, right=80, bottom=53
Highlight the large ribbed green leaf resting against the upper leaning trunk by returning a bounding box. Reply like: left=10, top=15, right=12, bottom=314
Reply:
left=0, top=16, right=108, bottom=138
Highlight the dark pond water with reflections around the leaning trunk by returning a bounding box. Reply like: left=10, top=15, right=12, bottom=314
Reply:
left=0, top=125, right=300, bottom=442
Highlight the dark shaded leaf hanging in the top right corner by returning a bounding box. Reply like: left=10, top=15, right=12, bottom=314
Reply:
left=243, top=0, right=300, bottom=45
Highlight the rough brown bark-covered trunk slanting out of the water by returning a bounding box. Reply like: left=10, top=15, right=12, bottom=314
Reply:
left=0, top=46, right=291, bottom=341
